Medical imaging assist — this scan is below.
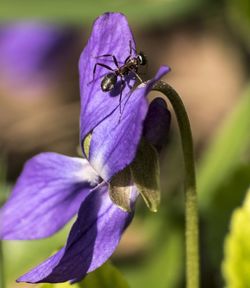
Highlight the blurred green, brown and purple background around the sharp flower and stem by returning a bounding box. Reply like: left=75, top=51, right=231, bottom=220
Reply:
left=0, top=0, right=250, bottom=288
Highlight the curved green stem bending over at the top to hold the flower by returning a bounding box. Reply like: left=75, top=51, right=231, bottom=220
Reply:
left=153, top=81, right=200, bottom=288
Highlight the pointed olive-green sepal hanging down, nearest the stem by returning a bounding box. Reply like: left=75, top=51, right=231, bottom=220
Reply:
left=130, top=139, right=161, bottom=212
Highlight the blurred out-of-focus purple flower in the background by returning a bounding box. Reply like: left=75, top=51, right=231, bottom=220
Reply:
left=0, top=22, right=72, bottom=89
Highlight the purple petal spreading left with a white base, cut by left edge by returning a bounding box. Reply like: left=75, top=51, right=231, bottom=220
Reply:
left=0, top=153, right=98, bottom=240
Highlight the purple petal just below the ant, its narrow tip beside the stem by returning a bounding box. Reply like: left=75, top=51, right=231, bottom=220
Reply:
left=89, top=66, right=169, bottom=181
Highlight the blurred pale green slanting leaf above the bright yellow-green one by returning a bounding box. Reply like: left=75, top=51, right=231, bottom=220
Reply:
left=197, top=85, right=250, bottom=211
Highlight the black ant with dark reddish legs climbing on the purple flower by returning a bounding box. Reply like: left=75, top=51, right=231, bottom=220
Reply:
left=93, top=41, right=147, bottom=94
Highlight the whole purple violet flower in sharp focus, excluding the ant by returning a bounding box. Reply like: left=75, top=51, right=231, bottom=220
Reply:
left=0, top=13, right=170, bottom=283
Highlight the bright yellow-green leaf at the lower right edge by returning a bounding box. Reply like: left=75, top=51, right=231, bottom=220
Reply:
left=222, top=189, right=250, bottom=288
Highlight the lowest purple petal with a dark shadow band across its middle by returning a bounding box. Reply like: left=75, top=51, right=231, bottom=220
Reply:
left=18, top=184, right=133, bottom=283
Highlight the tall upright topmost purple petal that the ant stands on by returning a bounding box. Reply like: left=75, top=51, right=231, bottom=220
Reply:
left=79, top=13, right=135, bottom=140
